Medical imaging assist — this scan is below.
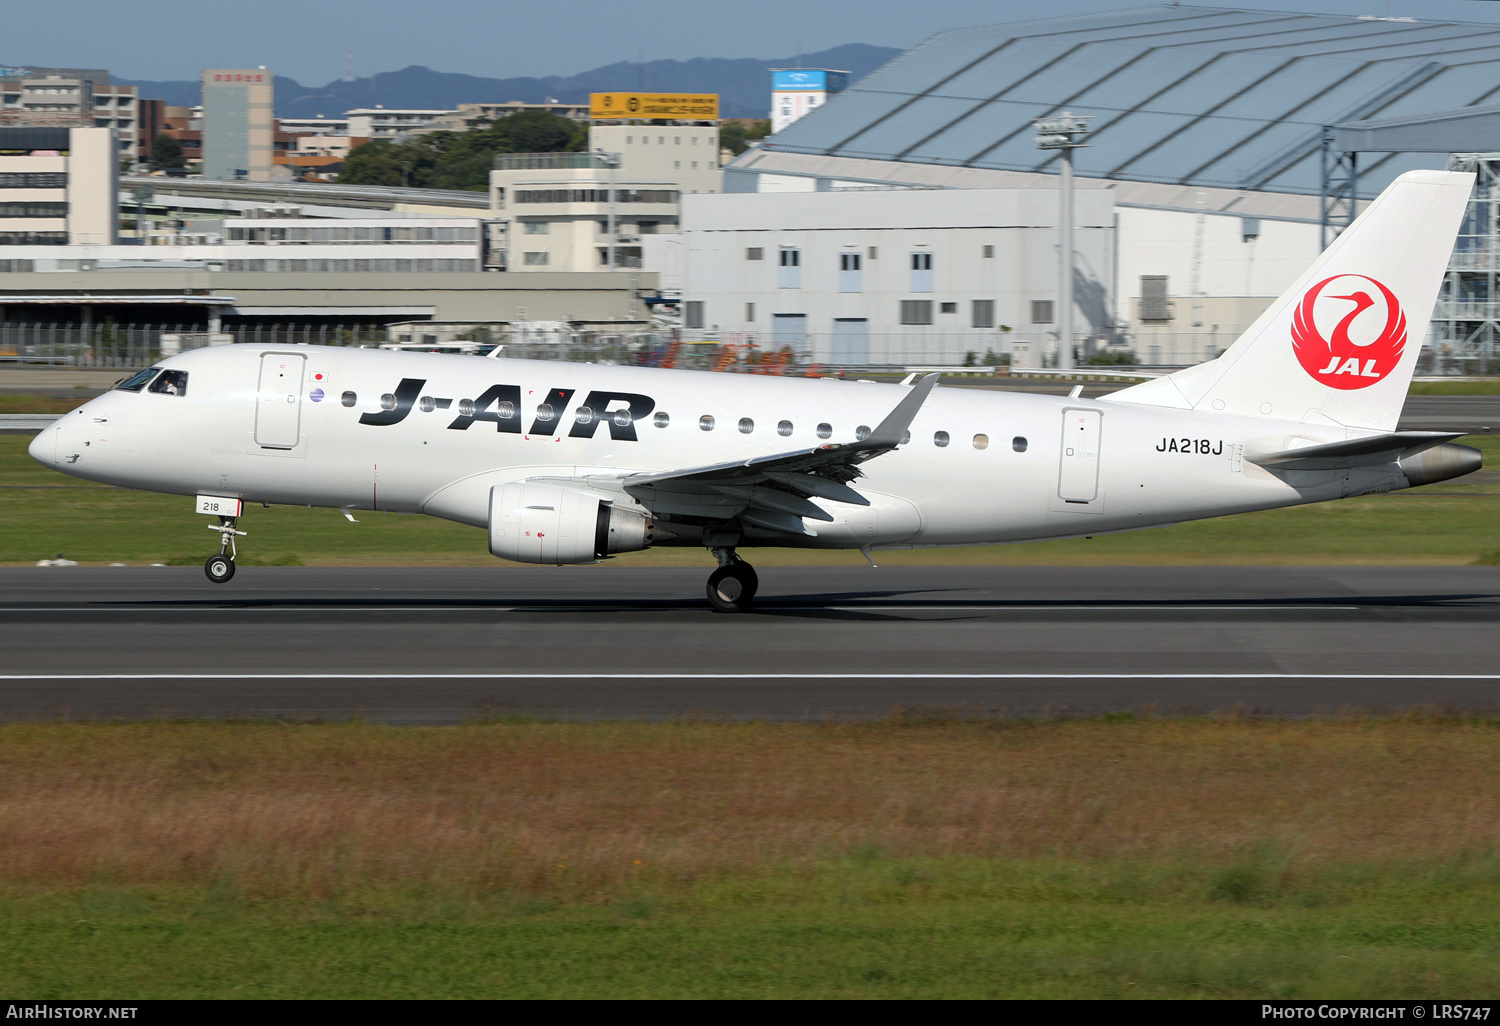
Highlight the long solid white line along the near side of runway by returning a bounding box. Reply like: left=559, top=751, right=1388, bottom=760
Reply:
left=0, top=672, right=1500, bottom=681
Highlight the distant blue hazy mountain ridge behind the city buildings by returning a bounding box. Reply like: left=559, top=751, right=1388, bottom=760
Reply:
left=114, top=44, right=902, bottom=117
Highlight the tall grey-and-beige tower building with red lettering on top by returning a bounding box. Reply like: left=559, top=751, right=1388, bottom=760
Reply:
left=201, top=68, right=276, bottom=182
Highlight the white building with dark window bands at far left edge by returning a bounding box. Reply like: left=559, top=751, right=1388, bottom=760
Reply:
left=0, top=125, right=119, bottom=243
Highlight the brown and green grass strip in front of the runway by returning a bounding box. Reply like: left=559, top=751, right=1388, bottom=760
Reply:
left=0, top=717, right=1500, bottom=998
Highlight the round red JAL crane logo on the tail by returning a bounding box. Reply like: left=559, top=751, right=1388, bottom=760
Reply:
left=1292, top=275, right=1407, bottom=389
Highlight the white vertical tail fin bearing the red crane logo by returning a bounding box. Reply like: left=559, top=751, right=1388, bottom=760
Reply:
left=1110, top=171, right=1475, bottom=431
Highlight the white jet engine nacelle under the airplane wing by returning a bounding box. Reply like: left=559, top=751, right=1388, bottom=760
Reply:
left=489, top=482, right=654, bottom=563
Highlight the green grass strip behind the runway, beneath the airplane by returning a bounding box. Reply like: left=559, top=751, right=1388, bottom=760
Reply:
left=0, top=435, right=1500, bottom=567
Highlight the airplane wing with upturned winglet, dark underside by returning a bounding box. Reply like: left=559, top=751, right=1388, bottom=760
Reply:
left=587, top=374, right=939, bottom=536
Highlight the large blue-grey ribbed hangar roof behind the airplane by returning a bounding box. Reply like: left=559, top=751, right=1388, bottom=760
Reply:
left=762, top=6, right=1500, bottom=197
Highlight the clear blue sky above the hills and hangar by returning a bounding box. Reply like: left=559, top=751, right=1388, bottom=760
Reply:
left=0, top=0, right=1500, bottom=86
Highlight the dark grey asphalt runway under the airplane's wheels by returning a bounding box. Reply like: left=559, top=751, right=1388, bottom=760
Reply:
left=0, top=566, right=1500, bottom=723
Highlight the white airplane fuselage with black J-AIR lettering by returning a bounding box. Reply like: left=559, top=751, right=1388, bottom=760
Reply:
left=32, top=345, right=1380, bottom=548
